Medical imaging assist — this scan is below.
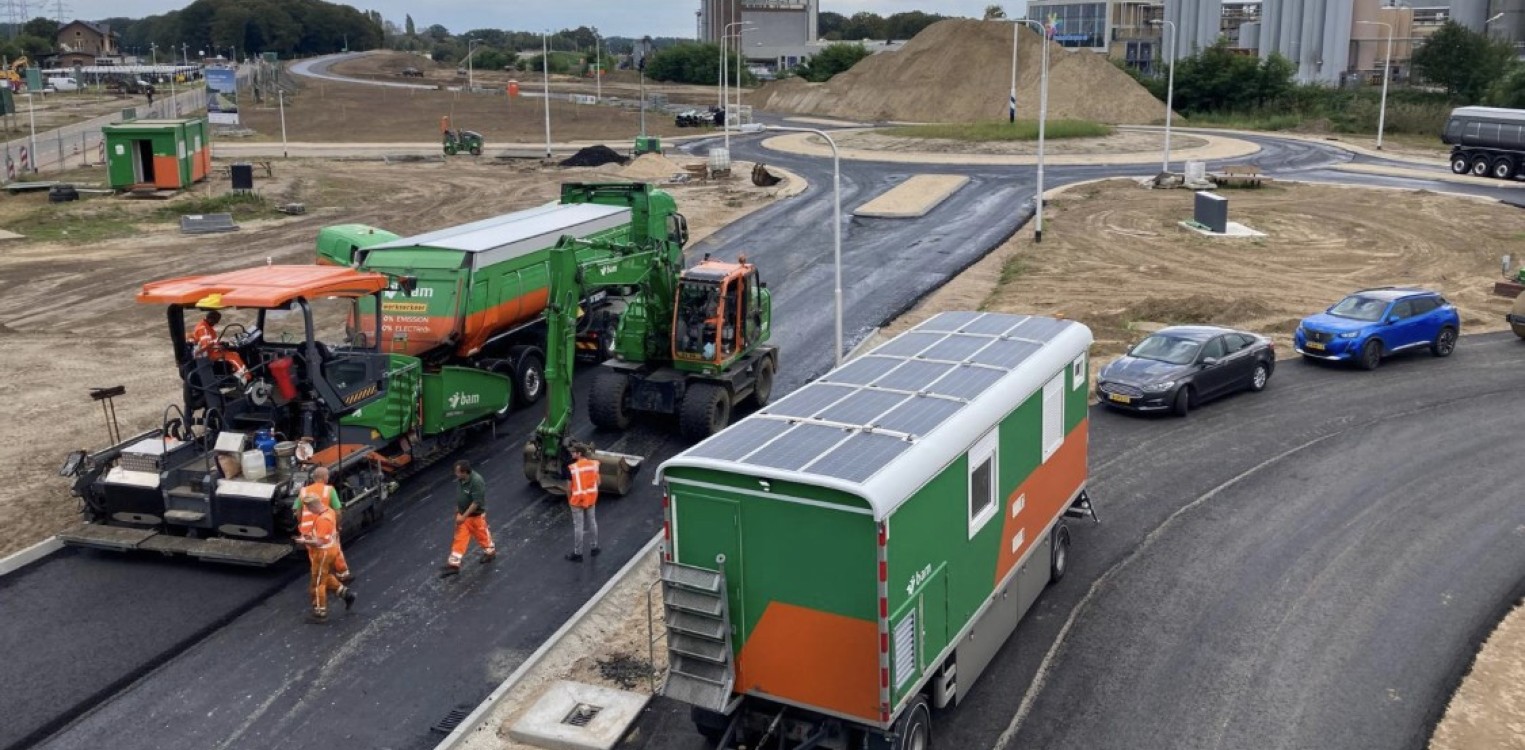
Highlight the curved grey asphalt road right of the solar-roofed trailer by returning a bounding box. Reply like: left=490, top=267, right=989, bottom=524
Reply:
left=622, top=334, right=1525, bottom=750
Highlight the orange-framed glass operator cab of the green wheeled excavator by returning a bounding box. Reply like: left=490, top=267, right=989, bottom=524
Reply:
left=673, top=256, right=772, bottom=372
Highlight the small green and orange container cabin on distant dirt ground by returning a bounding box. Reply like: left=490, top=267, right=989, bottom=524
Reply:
left=101, top=117, right=212, bottom=191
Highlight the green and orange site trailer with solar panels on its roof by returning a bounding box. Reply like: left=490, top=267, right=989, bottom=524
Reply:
left=657, top=313, right=1092, bottom=747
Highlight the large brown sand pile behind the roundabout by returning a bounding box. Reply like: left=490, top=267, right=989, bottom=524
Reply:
left=752, top=20, right=1165, bottom=125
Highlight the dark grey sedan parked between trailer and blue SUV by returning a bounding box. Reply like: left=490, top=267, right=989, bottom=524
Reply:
left=1096, top=326, right=1276, bottom=416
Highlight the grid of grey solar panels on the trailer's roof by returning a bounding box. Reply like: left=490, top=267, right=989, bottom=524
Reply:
left=685, top=313, right=1075, bottom=483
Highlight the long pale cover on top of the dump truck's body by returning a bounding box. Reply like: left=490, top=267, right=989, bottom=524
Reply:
left=366, top=203, right=630, bottom=268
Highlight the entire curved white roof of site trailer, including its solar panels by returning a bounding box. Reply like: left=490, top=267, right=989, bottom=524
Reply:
left=657, top=313, right=1092, bottom=518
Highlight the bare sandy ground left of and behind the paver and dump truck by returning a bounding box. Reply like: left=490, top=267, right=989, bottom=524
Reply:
left=0, top=160, right=798, bottom=556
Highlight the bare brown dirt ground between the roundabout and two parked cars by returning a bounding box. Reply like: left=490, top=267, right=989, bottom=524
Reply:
left=883, top=180, right=1520, bottom=361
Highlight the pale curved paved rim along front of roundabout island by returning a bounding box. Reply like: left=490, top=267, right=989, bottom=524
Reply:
left=763, top=128, right=1260, bottom=166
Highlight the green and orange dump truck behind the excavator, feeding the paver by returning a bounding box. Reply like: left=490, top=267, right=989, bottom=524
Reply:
left=317, top=183, right=688, bottom=405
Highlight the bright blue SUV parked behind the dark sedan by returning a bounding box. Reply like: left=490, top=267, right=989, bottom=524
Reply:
left=1292, top=287, right=1461, bottom=370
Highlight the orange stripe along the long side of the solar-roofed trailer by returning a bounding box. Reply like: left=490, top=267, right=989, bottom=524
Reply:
left=996, top=419, right=1090, bottom=585
